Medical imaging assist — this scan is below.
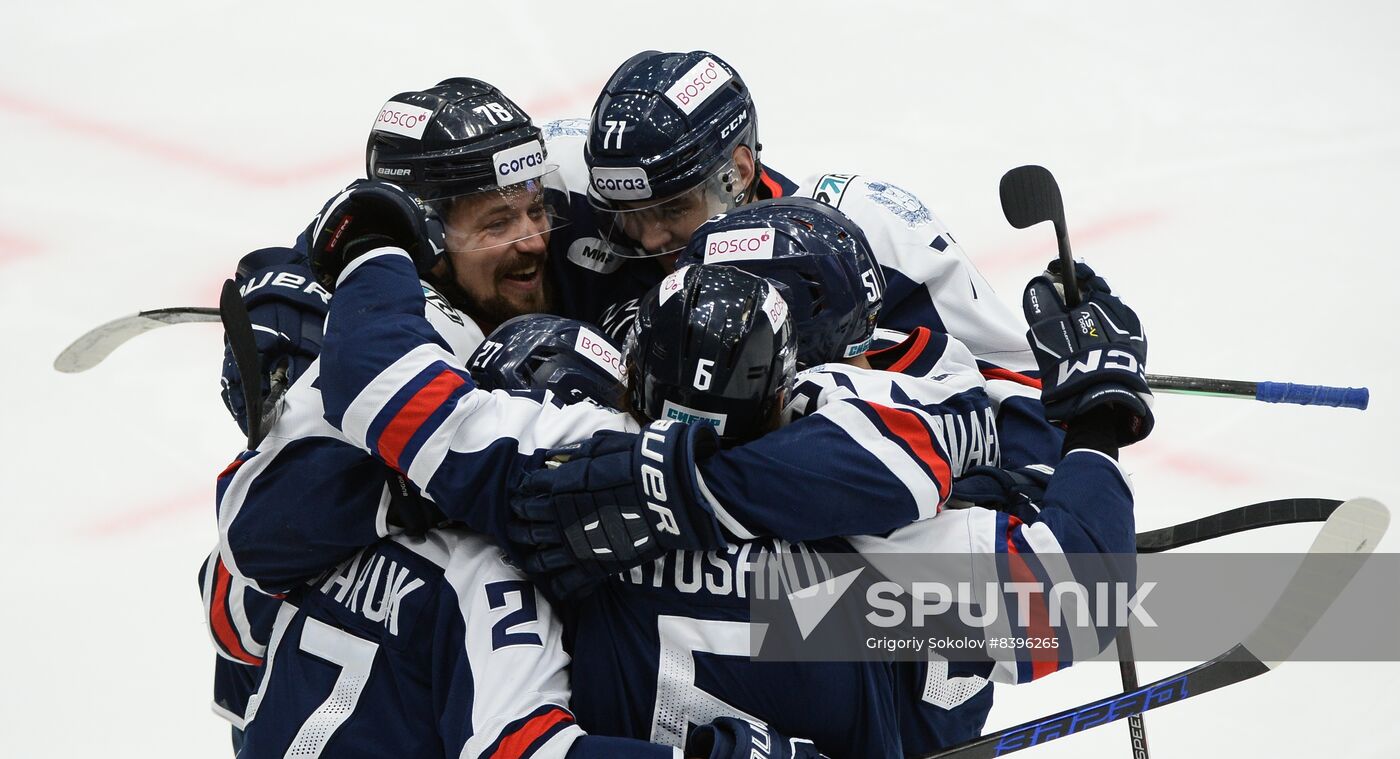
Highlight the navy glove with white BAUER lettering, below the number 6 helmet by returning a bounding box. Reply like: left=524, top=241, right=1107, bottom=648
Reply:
left=508, top=420, right=724, bottom=598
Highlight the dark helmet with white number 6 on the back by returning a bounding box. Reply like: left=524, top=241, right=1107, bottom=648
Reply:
left=626, top=266, right=797, bottom=443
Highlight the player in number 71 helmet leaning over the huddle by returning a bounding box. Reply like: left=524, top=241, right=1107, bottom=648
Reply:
left=543, top=50, right=1058, bottom=465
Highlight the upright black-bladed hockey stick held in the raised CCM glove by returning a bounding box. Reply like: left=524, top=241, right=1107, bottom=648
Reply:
left=998, top=165, right=1148, bottom=759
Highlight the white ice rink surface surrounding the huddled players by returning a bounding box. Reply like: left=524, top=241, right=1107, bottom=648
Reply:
left=0, top=0, right=1400, bottom=758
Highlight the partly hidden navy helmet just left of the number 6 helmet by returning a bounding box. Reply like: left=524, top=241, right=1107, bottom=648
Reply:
left=466, top=314, right=623, bottom=408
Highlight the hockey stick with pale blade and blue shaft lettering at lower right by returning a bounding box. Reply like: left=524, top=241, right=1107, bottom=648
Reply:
left=924, top=499, right=1390, bottom=759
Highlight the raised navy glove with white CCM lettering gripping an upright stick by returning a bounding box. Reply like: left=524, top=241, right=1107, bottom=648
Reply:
left=1022, top=262, right=1152, bottom=445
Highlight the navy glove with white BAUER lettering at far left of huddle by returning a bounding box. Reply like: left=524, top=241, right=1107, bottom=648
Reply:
left=220, top=248, right=330, bottom=434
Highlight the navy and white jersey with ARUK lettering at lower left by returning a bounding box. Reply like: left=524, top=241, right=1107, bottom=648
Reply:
left=239, top=531, right=672, bottom=759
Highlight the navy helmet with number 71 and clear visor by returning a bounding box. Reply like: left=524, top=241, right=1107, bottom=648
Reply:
left=584, top=50, right=760, bottom=255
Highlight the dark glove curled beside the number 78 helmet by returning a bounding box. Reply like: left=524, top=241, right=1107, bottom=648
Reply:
left=311, top=181, right=444, bottom=290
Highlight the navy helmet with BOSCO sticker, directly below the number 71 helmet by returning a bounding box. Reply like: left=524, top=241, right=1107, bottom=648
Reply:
left=676, top=197, right=885, bottom=367
